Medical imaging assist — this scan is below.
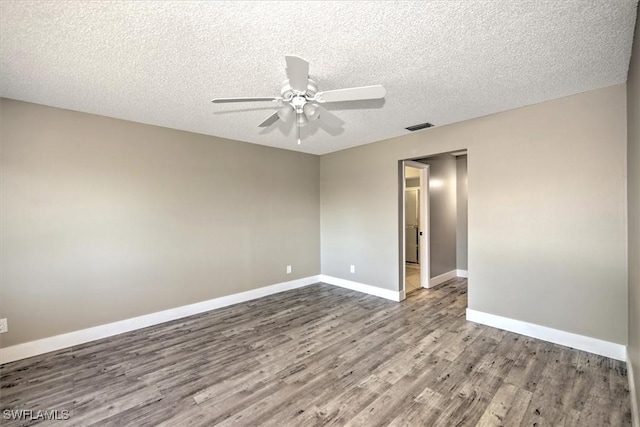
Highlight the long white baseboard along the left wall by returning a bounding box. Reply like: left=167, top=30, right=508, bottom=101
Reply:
left=0, top=276, right=320, bottom=364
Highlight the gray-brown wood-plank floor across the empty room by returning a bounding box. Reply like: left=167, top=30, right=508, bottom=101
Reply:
left=0, top=279, right=631, bottom=427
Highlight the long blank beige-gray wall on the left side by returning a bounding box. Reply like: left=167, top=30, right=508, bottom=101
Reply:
left=0, top=100, right=320, bottom=346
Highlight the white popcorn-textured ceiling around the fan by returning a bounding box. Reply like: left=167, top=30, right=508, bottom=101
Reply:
left=0, top=0, right=637, bottom=154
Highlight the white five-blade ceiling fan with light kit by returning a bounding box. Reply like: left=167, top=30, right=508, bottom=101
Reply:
left=211, top=55, right=387, bottom=144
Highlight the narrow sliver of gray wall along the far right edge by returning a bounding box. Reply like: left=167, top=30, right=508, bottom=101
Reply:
left=627, top=5, right=640, bottom=416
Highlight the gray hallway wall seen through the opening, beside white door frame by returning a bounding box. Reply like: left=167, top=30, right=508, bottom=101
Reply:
left=419, top=154, right=457, bottom=278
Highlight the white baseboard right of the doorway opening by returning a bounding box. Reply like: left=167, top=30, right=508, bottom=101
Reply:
left=467, top=308, right=627, bottom=362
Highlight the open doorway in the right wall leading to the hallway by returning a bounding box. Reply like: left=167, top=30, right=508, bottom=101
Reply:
left=398, top=150, right=468, bottom=297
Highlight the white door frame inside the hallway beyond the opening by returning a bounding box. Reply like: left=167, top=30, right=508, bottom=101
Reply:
left=400, top=160, right=431, bottom=296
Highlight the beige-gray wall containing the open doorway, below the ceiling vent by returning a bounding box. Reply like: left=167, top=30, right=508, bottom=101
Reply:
left=320, top=84, right=628, bottom=344
